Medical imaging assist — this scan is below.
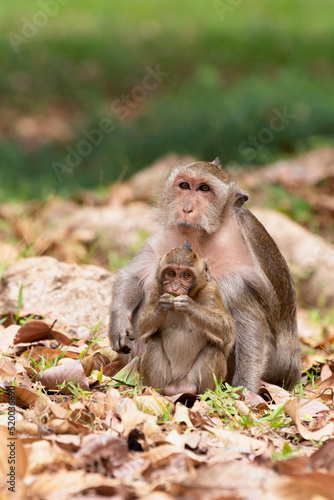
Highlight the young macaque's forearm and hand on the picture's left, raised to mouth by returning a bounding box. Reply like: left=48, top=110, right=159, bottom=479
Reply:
left=138, top=289, right=173, bottom=341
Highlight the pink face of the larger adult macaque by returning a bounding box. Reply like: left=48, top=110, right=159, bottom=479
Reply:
left=173, top=174, right=214, bottom=226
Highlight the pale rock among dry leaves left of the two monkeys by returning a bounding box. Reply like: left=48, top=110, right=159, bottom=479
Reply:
left=0, top=257, right=114, bottom=339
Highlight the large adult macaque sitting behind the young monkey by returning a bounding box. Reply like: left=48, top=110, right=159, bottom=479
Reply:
left=109, top=159, right=301, bottom=391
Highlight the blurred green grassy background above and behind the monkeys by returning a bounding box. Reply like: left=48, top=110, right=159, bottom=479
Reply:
left=0, top=0, right=334, bottom=200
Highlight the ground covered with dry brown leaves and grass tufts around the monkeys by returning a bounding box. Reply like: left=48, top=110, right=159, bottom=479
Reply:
left=0, top=150, right=334, bottom=500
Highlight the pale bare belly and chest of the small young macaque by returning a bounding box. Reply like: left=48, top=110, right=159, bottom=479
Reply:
left=162, top=311, right=205, bottom=372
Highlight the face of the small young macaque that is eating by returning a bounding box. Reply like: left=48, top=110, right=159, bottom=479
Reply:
left=161, top=265, right=196, bottom=295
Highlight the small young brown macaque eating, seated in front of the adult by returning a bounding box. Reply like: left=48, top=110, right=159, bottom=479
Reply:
left=138, top=245, right=235, bottom=396
